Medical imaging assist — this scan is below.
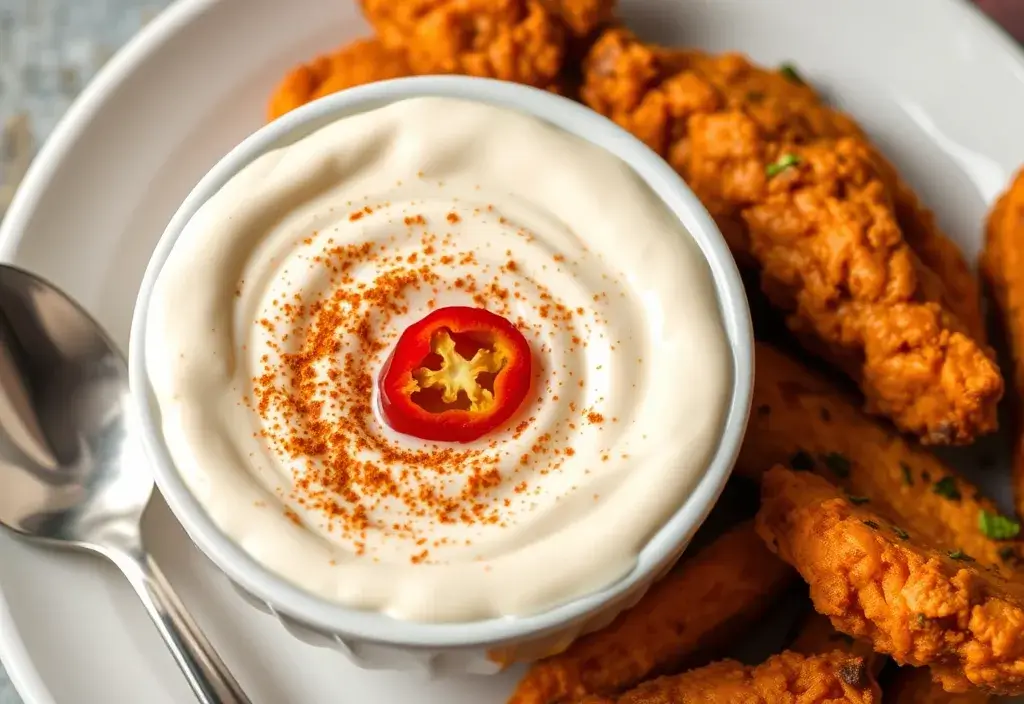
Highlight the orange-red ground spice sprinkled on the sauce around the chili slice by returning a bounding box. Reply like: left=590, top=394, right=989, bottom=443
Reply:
left=245, top=200, right=603, bottom=564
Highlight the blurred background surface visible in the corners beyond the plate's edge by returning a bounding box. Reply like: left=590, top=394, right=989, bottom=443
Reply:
left=0, top=0, right=1024, bottom=704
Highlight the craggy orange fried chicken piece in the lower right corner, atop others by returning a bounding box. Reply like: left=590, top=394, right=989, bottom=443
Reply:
left=757, top=467, right=1024, bottom=695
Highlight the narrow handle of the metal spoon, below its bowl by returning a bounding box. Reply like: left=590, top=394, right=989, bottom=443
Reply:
left=126, top=553, right=250, bottom=704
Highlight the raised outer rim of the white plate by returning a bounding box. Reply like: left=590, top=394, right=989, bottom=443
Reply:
left=0, top=0, right=1024, bottom=704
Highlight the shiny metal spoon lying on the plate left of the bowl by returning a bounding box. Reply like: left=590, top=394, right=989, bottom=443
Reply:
left=0, top=264, right=249, bottom=704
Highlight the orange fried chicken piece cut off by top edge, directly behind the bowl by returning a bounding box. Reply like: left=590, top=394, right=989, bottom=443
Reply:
left=360, top=0, right=569, bottom=89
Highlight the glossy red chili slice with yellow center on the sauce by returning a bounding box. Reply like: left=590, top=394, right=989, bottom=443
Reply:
left=378, top=306, right=532, bottom=442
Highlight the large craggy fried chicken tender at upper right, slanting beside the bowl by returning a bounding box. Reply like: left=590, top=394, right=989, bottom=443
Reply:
left=581, top=29, right=1002, bottom=444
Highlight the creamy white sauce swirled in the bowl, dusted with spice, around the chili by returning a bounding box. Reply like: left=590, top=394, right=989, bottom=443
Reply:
left=146, top=98, right=732, bottom=621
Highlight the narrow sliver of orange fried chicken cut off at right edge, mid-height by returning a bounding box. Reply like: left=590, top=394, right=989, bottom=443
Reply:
left=981, top=171, right=1024, bottom=516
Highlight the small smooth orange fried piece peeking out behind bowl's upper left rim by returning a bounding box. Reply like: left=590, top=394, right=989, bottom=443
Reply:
left=267, top=38, right=413, bottom=121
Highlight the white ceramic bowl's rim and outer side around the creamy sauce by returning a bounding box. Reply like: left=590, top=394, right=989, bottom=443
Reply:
left=129, top=77, right=753, bottom=673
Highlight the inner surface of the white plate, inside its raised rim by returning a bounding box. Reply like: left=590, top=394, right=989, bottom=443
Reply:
left=0, top=0, right=1024, bottom=704
